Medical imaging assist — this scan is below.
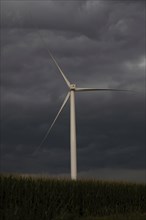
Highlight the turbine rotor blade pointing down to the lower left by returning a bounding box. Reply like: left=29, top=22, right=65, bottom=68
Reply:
left=33, top=92, right=70, bottom=154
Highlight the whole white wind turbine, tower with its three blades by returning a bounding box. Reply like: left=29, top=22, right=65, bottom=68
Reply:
left=38, top=51, right=127, bottom=180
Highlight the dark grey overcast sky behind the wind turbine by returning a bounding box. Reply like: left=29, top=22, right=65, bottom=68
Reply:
left=0, top=0, right=146, bottom=182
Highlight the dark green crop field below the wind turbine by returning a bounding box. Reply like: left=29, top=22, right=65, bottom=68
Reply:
left=0, top=175, right=146, bottom=220
